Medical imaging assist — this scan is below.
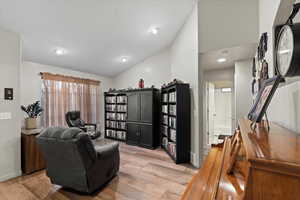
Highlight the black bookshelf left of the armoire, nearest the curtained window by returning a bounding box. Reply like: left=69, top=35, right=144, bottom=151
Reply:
left=104, top=91, right=127, bottom=141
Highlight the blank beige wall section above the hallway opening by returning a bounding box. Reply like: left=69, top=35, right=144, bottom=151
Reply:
left=199, top=0, right=258, bottom=52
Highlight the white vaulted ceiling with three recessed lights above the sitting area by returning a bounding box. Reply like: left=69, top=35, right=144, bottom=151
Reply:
left=0, top=0, right=195, bottom=76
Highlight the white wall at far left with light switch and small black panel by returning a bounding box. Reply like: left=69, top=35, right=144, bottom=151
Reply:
left=0, top=30, right=21, bottom=181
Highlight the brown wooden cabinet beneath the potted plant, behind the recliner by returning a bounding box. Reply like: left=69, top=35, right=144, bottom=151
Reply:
left=21, top=129, right=46, bottom=174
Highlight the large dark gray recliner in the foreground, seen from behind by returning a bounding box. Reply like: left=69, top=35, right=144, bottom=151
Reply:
left=37, top=127, right=120, bottom=193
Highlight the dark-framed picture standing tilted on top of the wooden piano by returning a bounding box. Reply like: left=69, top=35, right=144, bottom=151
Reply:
left=248, top=76, right=282, bottom=123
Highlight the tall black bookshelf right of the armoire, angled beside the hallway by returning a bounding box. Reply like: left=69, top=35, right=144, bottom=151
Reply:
left=160, top=83, right=191, bottom=164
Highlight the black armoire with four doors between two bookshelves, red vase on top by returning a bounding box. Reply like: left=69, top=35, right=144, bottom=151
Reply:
left=126, top=88, right=160, bottom=149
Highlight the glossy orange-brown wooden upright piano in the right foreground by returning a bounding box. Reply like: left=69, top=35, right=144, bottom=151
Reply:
left=182, top=119, right=300, bottom=200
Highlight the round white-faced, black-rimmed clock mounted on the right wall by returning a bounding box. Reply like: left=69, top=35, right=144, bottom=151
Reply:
left=275, top=3, right=300, bottom=77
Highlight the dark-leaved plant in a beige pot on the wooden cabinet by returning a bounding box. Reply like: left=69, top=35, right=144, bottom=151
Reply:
left=21, top=101, right=43, bottom=129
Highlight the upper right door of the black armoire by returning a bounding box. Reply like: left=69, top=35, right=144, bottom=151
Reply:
left=141, top=91, right=153, bottom=123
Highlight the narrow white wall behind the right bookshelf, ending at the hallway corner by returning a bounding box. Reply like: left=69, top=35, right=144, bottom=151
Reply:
left=170, top=6, right=202, bottom=166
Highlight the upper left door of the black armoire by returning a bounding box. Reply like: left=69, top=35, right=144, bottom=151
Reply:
left=127, top=93, right=141, bottom=122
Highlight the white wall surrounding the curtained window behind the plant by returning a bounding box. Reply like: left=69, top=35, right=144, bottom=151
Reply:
left=21, top=62, right=113, bottom=130
